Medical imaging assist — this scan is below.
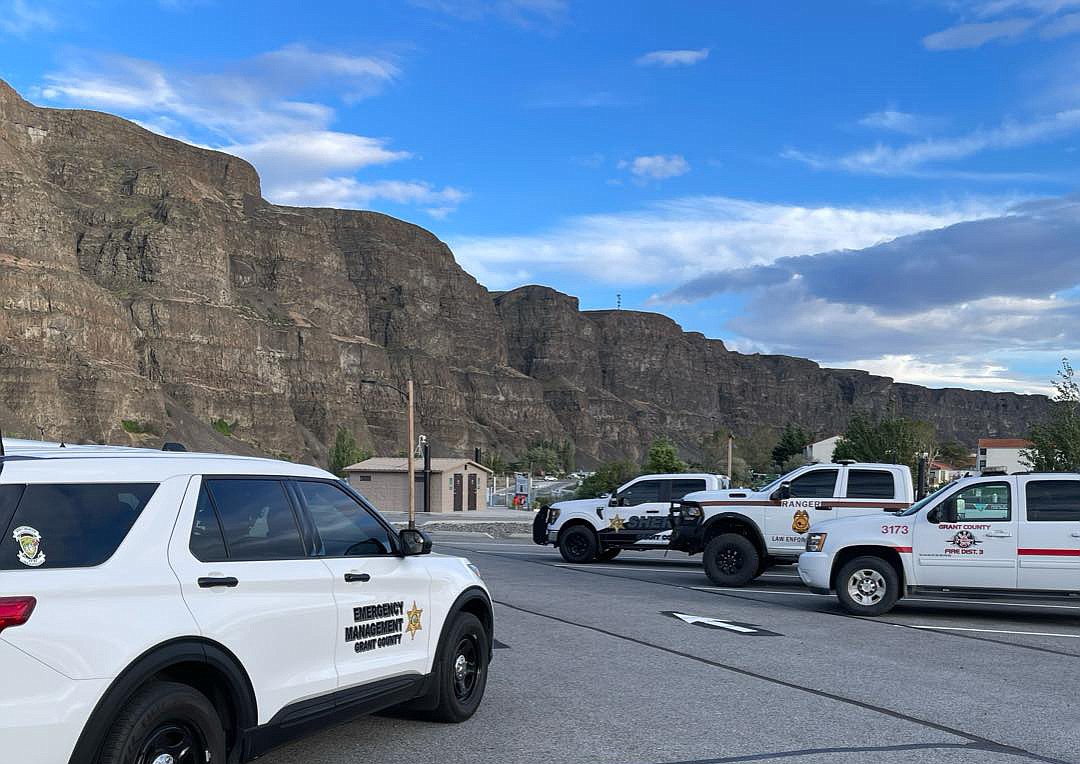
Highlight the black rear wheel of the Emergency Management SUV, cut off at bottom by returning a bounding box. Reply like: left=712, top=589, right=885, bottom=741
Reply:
left=98, top=682, right=226, bottom=764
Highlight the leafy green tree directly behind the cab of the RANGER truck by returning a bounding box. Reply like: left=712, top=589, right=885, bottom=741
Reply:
left=833, top=414, right=937, bottom=471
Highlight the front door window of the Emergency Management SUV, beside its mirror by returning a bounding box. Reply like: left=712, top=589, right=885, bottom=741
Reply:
left=295, top=480, right=394, bottom=558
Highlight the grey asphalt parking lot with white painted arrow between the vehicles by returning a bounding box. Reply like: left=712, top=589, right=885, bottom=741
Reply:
left=262, top=535, right=1080, bottom=764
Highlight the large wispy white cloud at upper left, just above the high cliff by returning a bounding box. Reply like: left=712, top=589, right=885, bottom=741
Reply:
left=32, top=45, right=467, bottom=217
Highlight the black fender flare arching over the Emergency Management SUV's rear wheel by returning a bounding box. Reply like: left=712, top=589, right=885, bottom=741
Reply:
left=69, top=636, right=258, bottom=764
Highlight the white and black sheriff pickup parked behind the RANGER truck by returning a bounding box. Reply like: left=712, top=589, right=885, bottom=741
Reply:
left=532, top=473, right=730, bottom=563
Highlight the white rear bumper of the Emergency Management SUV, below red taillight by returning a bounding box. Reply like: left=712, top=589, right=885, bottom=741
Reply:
left=0, top=639, right=108, bottom=764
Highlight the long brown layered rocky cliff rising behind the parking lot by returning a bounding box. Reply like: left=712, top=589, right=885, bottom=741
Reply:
left=0, top=82, right=1045, bottom=464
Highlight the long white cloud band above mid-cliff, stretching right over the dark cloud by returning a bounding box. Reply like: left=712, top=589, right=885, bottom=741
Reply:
left=450, top=197, right=993, bottom=291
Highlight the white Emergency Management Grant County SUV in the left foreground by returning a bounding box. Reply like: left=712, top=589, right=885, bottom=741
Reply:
left=0, top=441, right=492, bottom=764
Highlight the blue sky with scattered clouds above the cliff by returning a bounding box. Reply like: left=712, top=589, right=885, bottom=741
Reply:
left=0, top=0, right=1080, bottom=391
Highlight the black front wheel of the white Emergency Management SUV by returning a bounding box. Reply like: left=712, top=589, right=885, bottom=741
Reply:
left=426, top=613, right=489, bottom=724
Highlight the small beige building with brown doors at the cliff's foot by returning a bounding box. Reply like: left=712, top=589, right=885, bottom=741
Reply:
left=345, top=456, right=492, bottom=512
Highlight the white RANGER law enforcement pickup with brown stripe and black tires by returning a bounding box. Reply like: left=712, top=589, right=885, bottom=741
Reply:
left=670, top=461, right=914, bottom=587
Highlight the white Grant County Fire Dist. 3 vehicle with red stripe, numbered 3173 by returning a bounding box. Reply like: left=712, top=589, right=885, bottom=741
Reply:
left=798, top=472, right=1080, bottom=616
